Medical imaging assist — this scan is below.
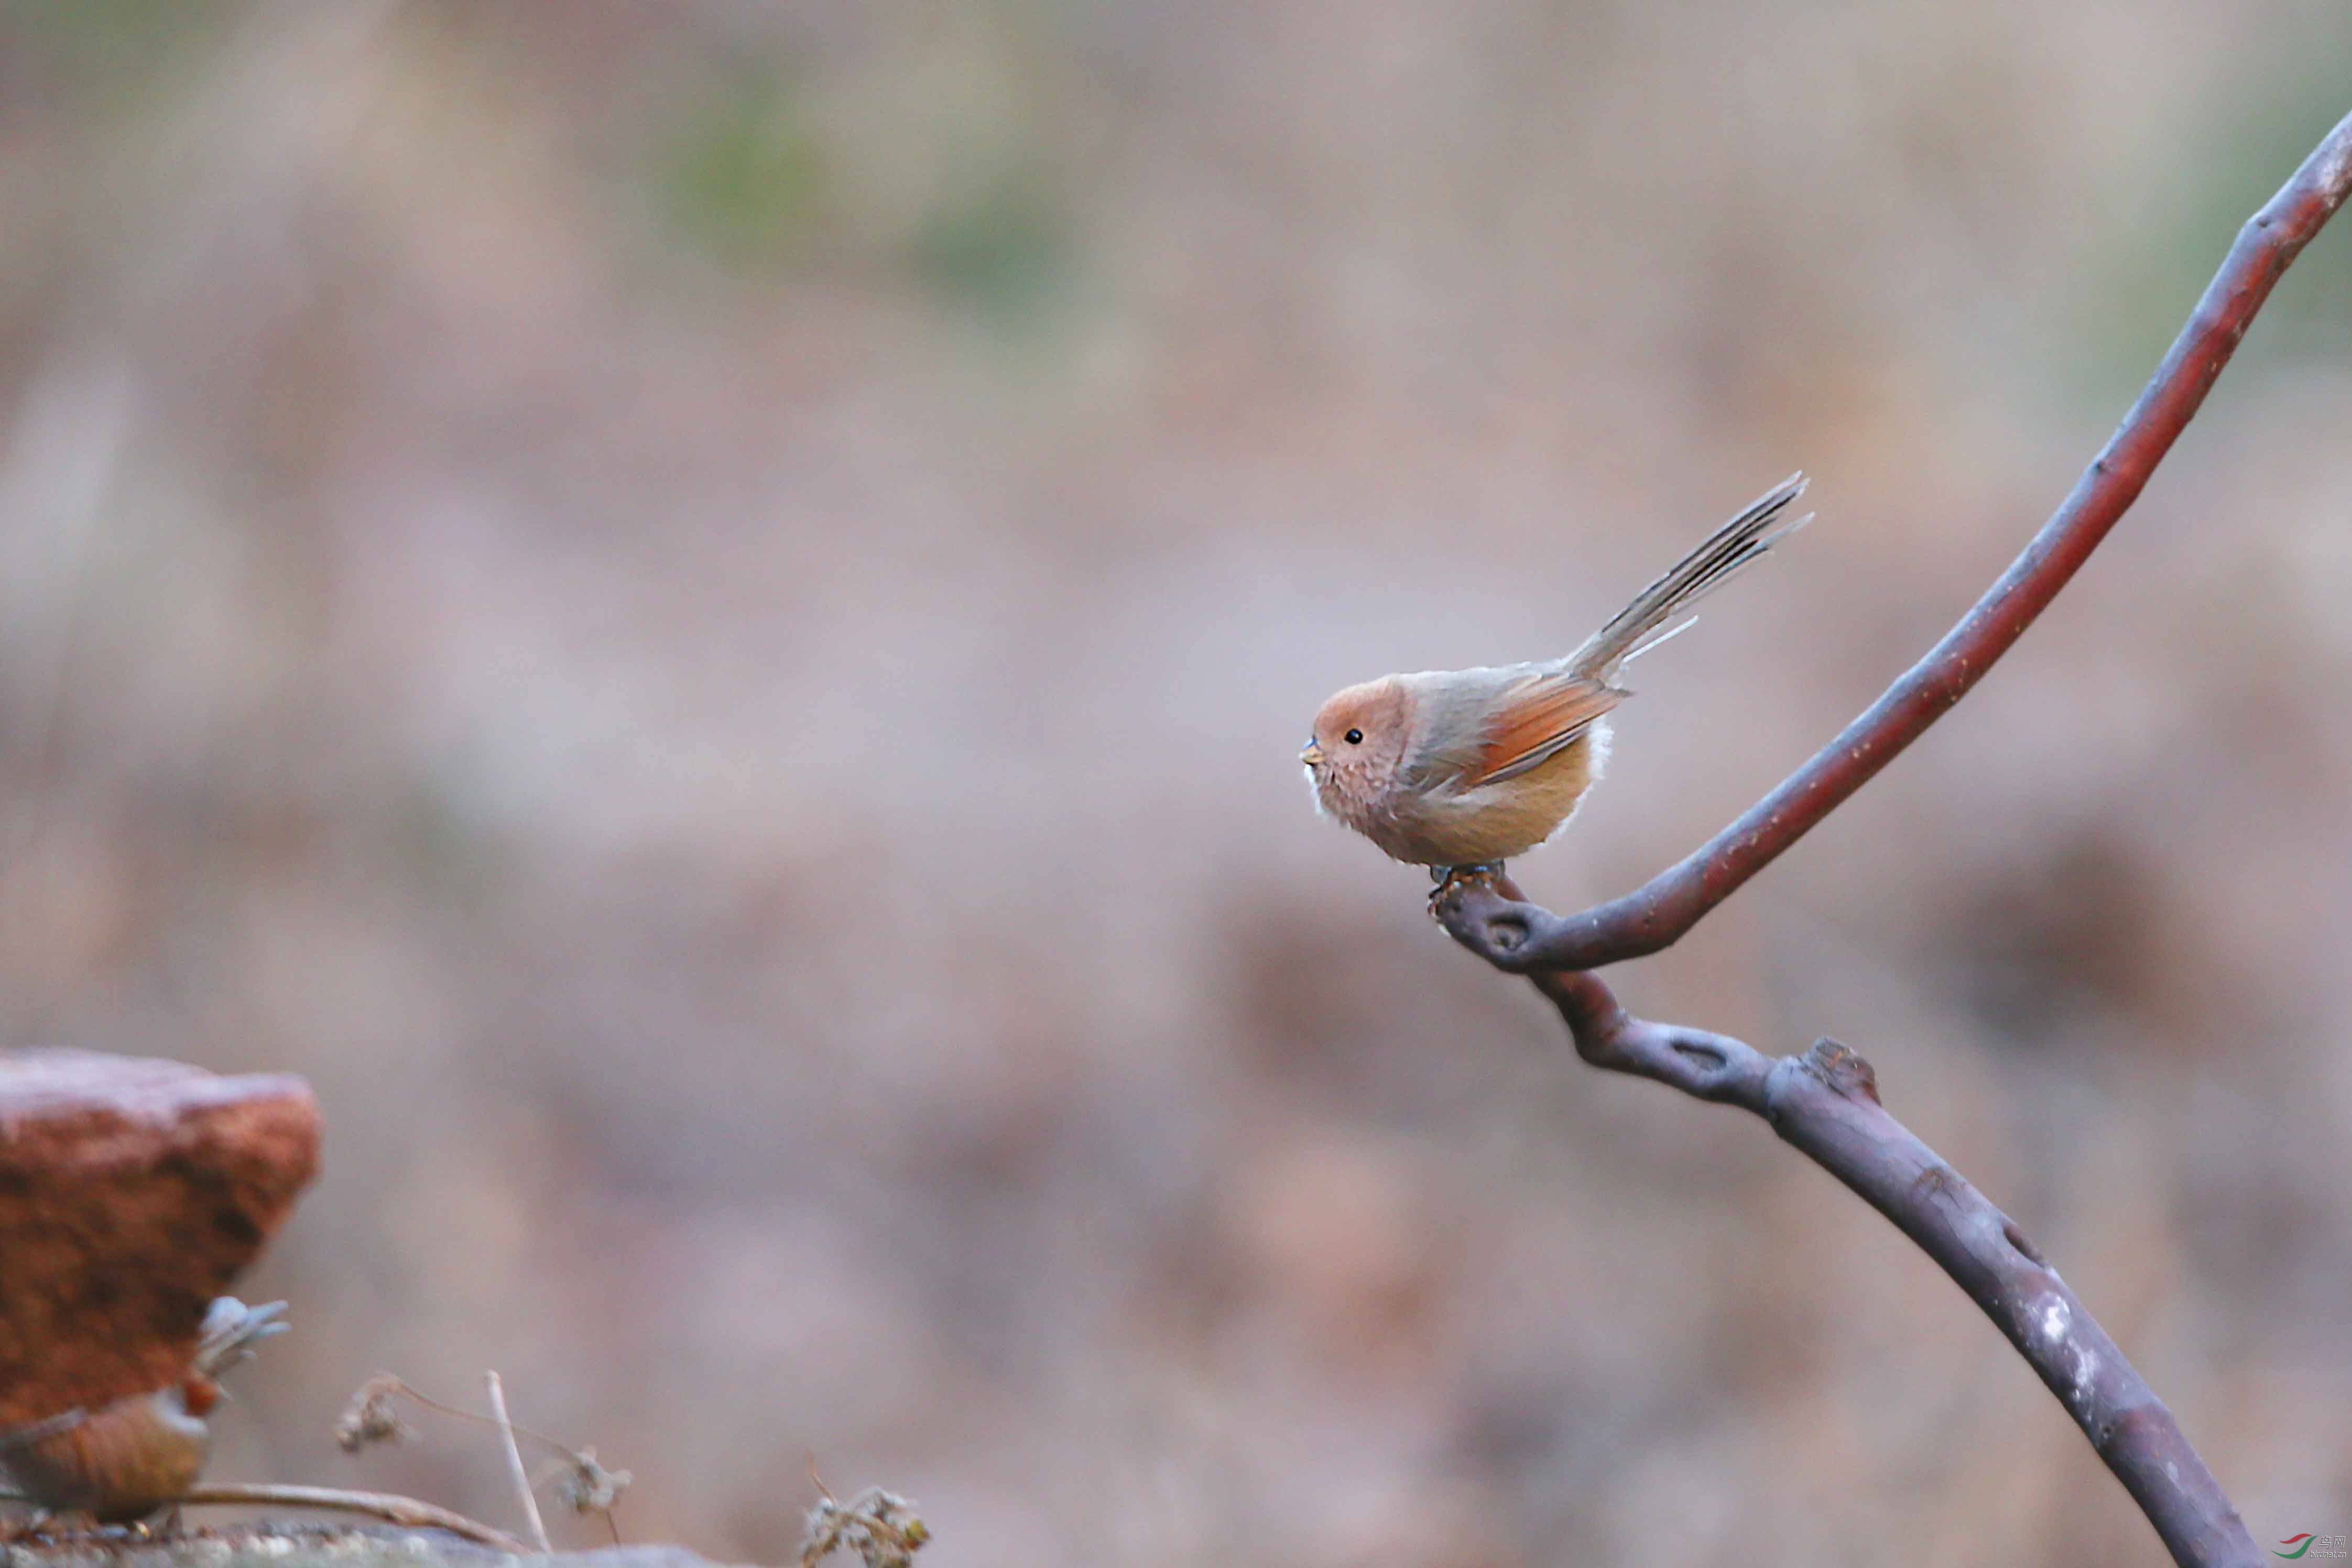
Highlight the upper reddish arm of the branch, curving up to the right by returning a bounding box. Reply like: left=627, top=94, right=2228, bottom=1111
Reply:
left=1456, top=115, right=2352, bottom=973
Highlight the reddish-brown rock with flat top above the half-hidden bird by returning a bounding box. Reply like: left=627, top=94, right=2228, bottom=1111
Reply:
left=0, top=1051, right=318, bottom=1427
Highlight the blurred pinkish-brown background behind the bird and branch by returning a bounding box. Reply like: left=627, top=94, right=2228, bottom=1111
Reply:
left=0, top=0, right=2352, bottom=1568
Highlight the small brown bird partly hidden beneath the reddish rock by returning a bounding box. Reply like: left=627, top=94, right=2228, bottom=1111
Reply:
left=0, top=1295, right=287, bottom=1523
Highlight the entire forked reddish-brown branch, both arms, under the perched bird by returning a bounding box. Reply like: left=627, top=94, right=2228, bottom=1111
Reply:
left=1435, top=117, right=2352, bottom=1566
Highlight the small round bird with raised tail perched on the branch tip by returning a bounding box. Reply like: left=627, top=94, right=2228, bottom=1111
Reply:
left=1298, top=475, right=1811, bottom=886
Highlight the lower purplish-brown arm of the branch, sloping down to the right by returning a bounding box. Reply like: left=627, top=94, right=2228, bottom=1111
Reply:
left=1444, top=877, right=2262, bottom=1566
